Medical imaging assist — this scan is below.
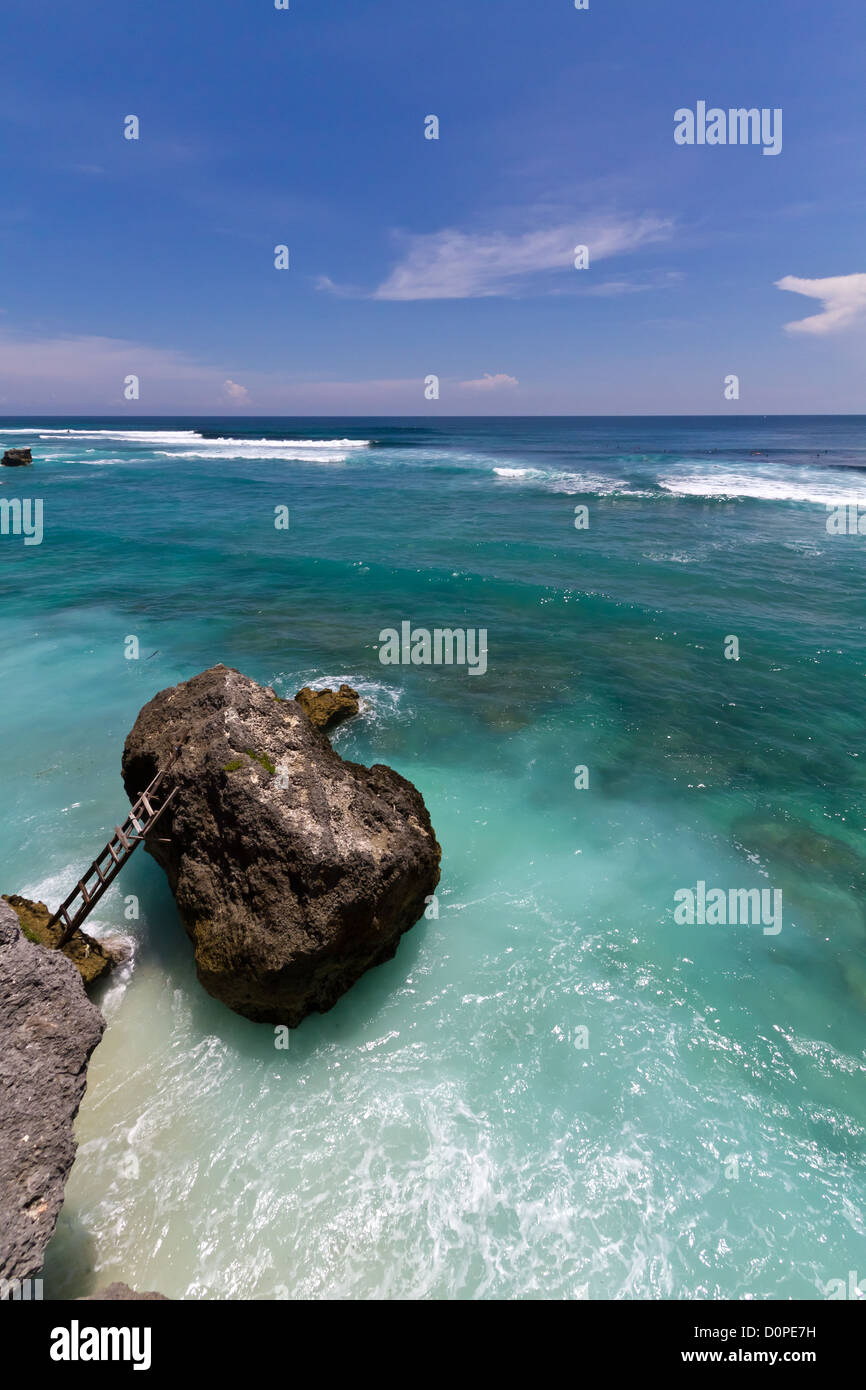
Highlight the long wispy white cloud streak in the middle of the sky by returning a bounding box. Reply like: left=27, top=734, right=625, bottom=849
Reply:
left=318, top=217, right=673, bottom=300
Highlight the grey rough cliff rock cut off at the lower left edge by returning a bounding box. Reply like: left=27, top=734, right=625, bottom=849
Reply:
left=0, top=901, right=106, bottom=1279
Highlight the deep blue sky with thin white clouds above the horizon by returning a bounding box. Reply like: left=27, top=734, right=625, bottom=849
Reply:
left=0, top=0, right=866, bottom=416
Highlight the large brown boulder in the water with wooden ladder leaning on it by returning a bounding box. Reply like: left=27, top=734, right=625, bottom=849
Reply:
left=124, top=666, right=439, bottom=1027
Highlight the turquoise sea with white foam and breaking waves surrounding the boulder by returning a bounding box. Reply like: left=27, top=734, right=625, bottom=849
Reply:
left=0, top=418, right=866, bottom=1298
